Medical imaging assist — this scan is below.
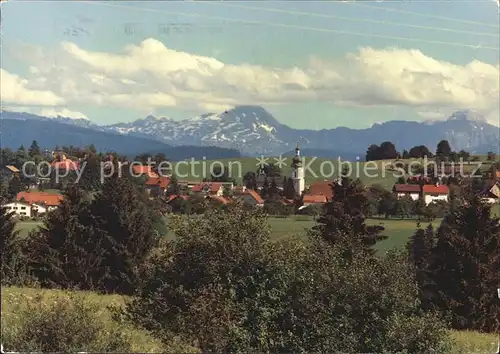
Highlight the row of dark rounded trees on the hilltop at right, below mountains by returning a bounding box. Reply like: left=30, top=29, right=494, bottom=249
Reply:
left=365, top=140, right=496, bottom=162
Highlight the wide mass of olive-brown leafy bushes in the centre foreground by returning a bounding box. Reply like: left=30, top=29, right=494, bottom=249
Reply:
left=124, top=206, right=449, bottom=353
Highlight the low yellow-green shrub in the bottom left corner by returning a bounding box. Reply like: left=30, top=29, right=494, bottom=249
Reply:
left=2, top=293, right=132, bottom=353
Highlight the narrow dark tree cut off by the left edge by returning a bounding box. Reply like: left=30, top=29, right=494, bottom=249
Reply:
left=0, top=197, right=20, bottom=285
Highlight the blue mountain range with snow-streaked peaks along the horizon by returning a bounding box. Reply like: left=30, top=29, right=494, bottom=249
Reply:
left=2, top=106, right=500, bottom=160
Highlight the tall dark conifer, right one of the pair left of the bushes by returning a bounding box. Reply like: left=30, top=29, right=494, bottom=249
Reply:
left=91, top=174, right=156, bottom=294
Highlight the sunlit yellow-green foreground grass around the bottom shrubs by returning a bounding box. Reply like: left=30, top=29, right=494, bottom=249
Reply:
left=1, top=287, right=498, bottom=354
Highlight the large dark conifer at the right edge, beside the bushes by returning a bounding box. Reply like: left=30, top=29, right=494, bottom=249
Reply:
left=429, top=190, right=500, bottom=332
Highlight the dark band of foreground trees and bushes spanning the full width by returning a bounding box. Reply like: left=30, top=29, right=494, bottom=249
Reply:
left=0, top=173, right=500, bottom=353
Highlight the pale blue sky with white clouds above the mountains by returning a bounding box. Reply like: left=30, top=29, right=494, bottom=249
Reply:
left=0, top=0, right=500, bottom=129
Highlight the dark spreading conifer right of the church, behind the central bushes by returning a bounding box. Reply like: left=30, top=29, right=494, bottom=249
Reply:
left=314, top=177, right=387, bottom=253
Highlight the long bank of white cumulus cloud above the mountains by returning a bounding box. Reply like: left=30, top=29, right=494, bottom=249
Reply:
left=2, top=39, right=500, bottom=124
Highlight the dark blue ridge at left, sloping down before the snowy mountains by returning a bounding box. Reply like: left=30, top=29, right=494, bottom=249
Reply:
left=0, top=112, right=241, bottom=161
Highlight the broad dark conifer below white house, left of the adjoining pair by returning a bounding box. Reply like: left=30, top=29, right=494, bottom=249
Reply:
left=24, top=185, right=104, bottom=290
